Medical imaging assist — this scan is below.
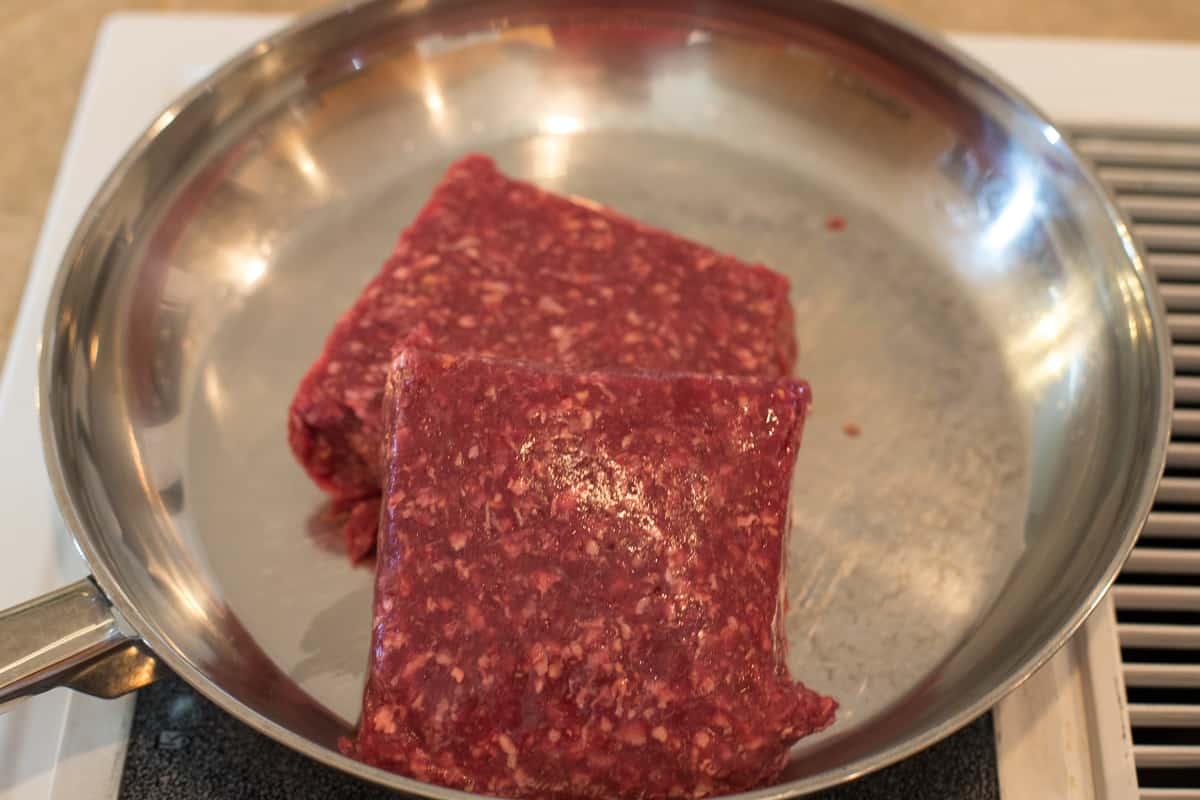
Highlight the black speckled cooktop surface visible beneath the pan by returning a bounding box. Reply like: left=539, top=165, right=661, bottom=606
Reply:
left=119, top=676, right=1000, bottom=800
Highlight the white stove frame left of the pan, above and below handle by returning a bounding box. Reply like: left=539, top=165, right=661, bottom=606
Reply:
left=0, top=14, right=287, bottom=800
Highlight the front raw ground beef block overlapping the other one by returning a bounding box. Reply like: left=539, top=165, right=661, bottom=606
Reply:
left=344, top=350, right=836, bottom=799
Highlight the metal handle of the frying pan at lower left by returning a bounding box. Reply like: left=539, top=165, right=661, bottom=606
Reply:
left=0, top=578, right=160, bottom=712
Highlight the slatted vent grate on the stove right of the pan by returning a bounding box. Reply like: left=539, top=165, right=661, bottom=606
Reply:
left=1074, top=131, right=1200, bottom=800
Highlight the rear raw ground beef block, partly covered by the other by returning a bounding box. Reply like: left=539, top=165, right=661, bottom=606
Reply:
left=288, top=156, right=796, bottom=557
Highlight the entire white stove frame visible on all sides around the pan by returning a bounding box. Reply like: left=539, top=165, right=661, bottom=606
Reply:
left=0, top=13, right=1200, bottom=800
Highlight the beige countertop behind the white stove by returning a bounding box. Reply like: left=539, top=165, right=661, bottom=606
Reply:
left=0, top=0, right=1200, bottom=353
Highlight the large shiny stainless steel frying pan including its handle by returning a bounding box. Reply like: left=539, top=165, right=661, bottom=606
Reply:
left=0, top=0, right=1171, bottom=798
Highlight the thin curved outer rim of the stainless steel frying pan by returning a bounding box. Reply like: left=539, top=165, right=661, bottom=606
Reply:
left=37, top=0, right=1174, bottom=800
